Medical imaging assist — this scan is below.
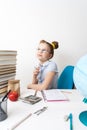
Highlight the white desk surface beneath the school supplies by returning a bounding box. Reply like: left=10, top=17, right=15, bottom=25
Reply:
left=0, top=90, right=87, bottom=130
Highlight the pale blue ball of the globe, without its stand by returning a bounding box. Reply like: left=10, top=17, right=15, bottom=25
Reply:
left=73, top=54, right=87, bottom=98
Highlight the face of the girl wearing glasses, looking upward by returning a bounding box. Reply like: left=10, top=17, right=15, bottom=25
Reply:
left=37, top=43, right=52, bottom=63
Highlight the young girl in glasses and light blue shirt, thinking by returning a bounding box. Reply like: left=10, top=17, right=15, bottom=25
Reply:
left=27, top=40, right=59, bottom=91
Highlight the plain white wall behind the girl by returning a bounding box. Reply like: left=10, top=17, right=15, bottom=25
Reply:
left=0, top=0, right=87, bottom=87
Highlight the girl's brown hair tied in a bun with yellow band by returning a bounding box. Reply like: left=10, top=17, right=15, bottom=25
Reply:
left=40, top=40, right=59, bottom=58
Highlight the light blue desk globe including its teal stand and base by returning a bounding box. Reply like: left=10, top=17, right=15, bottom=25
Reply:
left=73, top=55, right=87, bottom=126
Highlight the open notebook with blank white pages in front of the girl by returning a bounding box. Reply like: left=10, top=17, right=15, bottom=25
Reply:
left=42, top=89, right=68, bottom=102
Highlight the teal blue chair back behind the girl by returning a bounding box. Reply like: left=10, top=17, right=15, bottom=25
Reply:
left=57, top=65, right=74, bottom=89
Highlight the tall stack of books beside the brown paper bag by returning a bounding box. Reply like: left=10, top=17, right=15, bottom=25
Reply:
left=0, top=50, right=17, bottom=95
